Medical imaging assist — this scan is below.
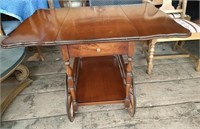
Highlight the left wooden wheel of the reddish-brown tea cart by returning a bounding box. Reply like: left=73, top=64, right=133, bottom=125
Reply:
left=65, top=74, right=75, bottom=122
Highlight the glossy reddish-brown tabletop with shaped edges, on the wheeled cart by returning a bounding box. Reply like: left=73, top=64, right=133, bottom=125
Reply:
left=2, top=3, right=190, bottom=47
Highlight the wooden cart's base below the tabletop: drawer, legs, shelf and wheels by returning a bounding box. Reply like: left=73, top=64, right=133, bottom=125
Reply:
left=61, top=42, right=136, bottom=121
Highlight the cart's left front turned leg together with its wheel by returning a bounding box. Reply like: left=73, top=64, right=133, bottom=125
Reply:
left=61, top=45, right=78, bottom=122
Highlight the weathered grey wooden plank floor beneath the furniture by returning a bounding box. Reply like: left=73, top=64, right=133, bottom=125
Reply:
left=1, top=43, right=200, bottom=129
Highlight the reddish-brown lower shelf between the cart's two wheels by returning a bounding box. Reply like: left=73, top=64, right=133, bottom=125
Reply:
left=76, top=56, right=125, bottom=104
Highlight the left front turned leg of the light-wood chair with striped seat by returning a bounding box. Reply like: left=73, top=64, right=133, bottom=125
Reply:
left=147, top=40, right=156, bottom=74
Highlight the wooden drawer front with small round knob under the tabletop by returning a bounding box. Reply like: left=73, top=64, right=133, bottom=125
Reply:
left=68, top=42, right=128, bottom=57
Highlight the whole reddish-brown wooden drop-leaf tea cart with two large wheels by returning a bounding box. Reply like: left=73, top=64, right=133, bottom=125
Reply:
left=1, top=3, right=191, bottom=121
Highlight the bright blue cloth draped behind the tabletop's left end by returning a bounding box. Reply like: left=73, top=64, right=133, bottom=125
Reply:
left=0, top=0, right=60, bottom=22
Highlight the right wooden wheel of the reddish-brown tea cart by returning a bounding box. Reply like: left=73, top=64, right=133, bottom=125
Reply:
left=128, top=80, right=136, bottom=117
